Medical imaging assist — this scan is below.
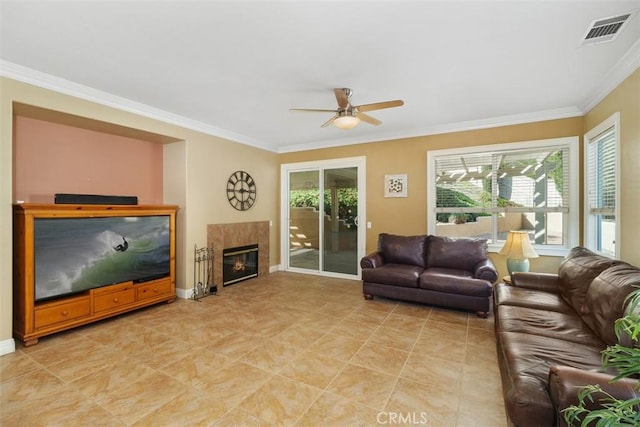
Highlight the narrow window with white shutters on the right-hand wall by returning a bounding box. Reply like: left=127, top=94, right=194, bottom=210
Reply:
left=584, top=113, right=620, bottom=257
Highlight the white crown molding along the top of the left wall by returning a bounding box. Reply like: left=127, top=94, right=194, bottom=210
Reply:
left=0, top=59, right=274, bottom=151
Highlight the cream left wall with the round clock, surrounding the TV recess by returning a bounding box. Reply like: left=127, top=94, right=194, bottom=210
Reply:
left=0, top=78, right=280, bottom=352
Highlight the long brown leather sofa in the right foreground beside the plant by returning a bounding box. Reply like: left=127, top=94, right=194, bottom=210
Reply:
left=494, top=247, right=640, bottom=427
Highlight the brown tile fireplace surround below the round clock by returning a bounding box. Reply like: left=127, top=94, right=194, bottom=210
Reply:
left=207, top=221, right=269, bottom=291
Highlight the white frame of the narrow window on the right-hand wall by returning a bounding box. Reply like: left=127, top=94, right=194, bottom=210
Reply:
left=584, top=113, right=621, bottom=258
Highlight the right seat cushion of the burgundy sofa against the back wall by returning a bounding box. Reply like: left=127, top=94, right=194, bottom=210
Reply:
left=418, top=268, right=493, bottom=297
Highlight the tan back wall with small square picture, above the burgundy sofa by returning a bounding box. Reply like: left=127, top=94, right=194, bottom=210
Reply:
left=280, top=117, right=583, bottom=275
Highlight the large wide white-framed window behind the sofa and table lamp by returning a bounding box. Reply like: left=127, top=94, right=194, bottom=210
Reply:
left=427, top=137, right=579, bottom=255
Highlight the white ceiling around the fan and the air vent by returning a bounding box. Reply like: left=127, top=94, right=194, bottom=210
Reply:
left=0, top=0, right=640, bottom=152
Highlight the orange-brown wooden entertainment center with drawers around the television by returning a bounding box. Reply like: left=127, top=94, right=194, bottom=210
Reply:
left=13, top=203, right=178, bottom=346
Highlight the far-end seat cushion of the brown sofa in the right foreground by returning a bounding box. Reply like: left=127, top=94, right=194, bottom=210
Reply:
left=494, top=283, right=575, bottom=313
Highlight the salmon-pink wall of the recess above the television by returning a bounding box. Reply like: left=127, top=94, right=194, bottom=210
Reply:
left=13, top=116, right=163, bottom=204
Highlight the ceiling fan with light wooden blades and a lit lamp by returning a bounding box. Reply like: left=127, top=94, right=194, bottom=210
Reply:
left=290, top=88, right=404, bottom=129
